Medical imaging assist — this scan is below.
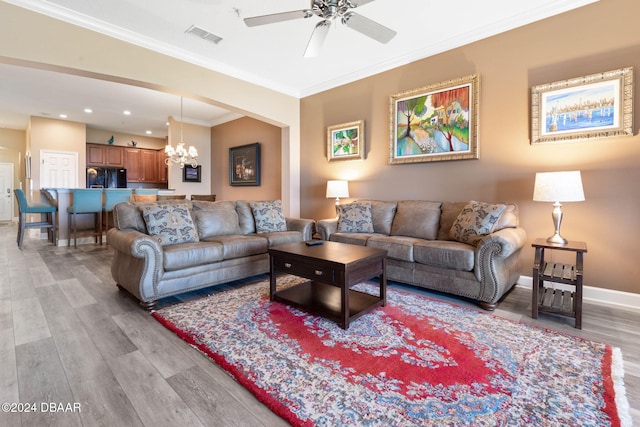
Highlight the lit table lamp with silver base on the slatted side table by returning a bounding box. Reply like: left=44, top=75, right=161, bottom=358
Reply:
left=533, top=171, right=584, bottom=245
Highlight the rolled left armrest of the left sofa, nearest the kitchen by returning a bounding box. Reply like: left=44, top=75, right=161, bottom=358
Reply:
left=107, top=228, right=164, bottom=302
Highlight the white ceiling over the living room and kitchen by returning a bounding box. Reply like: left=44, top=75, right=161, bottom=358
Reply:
left=0, top=0, right=597, bottom=136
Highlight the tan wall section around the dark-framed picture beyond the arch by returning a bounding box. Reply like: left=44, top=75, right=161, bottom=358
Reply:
left=211, top=117, right=282, bottom=200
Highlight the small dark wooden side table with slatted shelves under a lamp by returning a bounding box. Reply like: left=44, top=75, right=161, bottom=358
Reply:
left=531, top=239, right=587, bottom=329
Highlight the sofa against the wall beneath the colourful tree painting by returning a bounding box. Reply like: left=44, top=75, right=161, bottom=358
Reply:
left=316, top=200, right=526, bottom=310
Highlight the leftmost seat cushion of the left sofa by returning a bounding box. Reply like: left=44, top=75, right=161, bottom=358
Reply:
left=162, top=242, right=223, bottom=271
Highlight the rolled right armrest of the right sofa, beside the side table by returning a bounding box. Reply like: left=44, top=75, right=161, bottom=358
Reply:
left=475, top=227, right=527, bottom=303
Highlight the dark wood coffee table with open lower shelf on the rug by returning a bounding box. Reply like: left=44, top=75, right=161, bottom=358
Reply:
left=269, top=241, right=387, bottom=329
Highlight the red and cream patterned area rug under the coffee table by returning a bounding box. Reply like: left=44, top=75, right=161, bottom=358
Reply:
left=153, top=277, right=631, bottom=427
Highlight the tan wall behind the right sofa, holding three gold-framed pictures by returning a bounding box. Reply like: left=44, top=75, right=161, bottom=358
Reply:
left=300, top=0, right=640, bottom=293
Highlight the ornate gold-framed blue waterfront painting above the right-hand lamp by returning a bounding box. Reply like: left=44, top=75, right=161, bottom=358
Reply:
left=531, top=67, right=633, bottom=144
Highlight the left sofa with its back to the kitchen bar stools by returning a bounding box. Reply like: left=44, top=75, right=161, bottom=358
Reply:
left=107, top=200, right=315, bottom=310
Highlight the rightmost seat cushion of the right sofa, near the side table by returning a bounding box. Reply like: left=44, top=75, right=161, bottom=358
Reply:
left=413, top=240, right=475, bottom=271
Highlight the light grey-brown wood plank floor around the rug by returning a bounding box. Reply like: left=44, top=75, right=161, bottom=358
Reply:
left=0, top=225, right=640, bottom=427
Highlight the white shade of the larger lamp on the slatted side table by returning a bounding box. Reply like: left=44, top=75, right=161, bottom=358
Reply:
left=533, top=171, right=584, bottom=202
